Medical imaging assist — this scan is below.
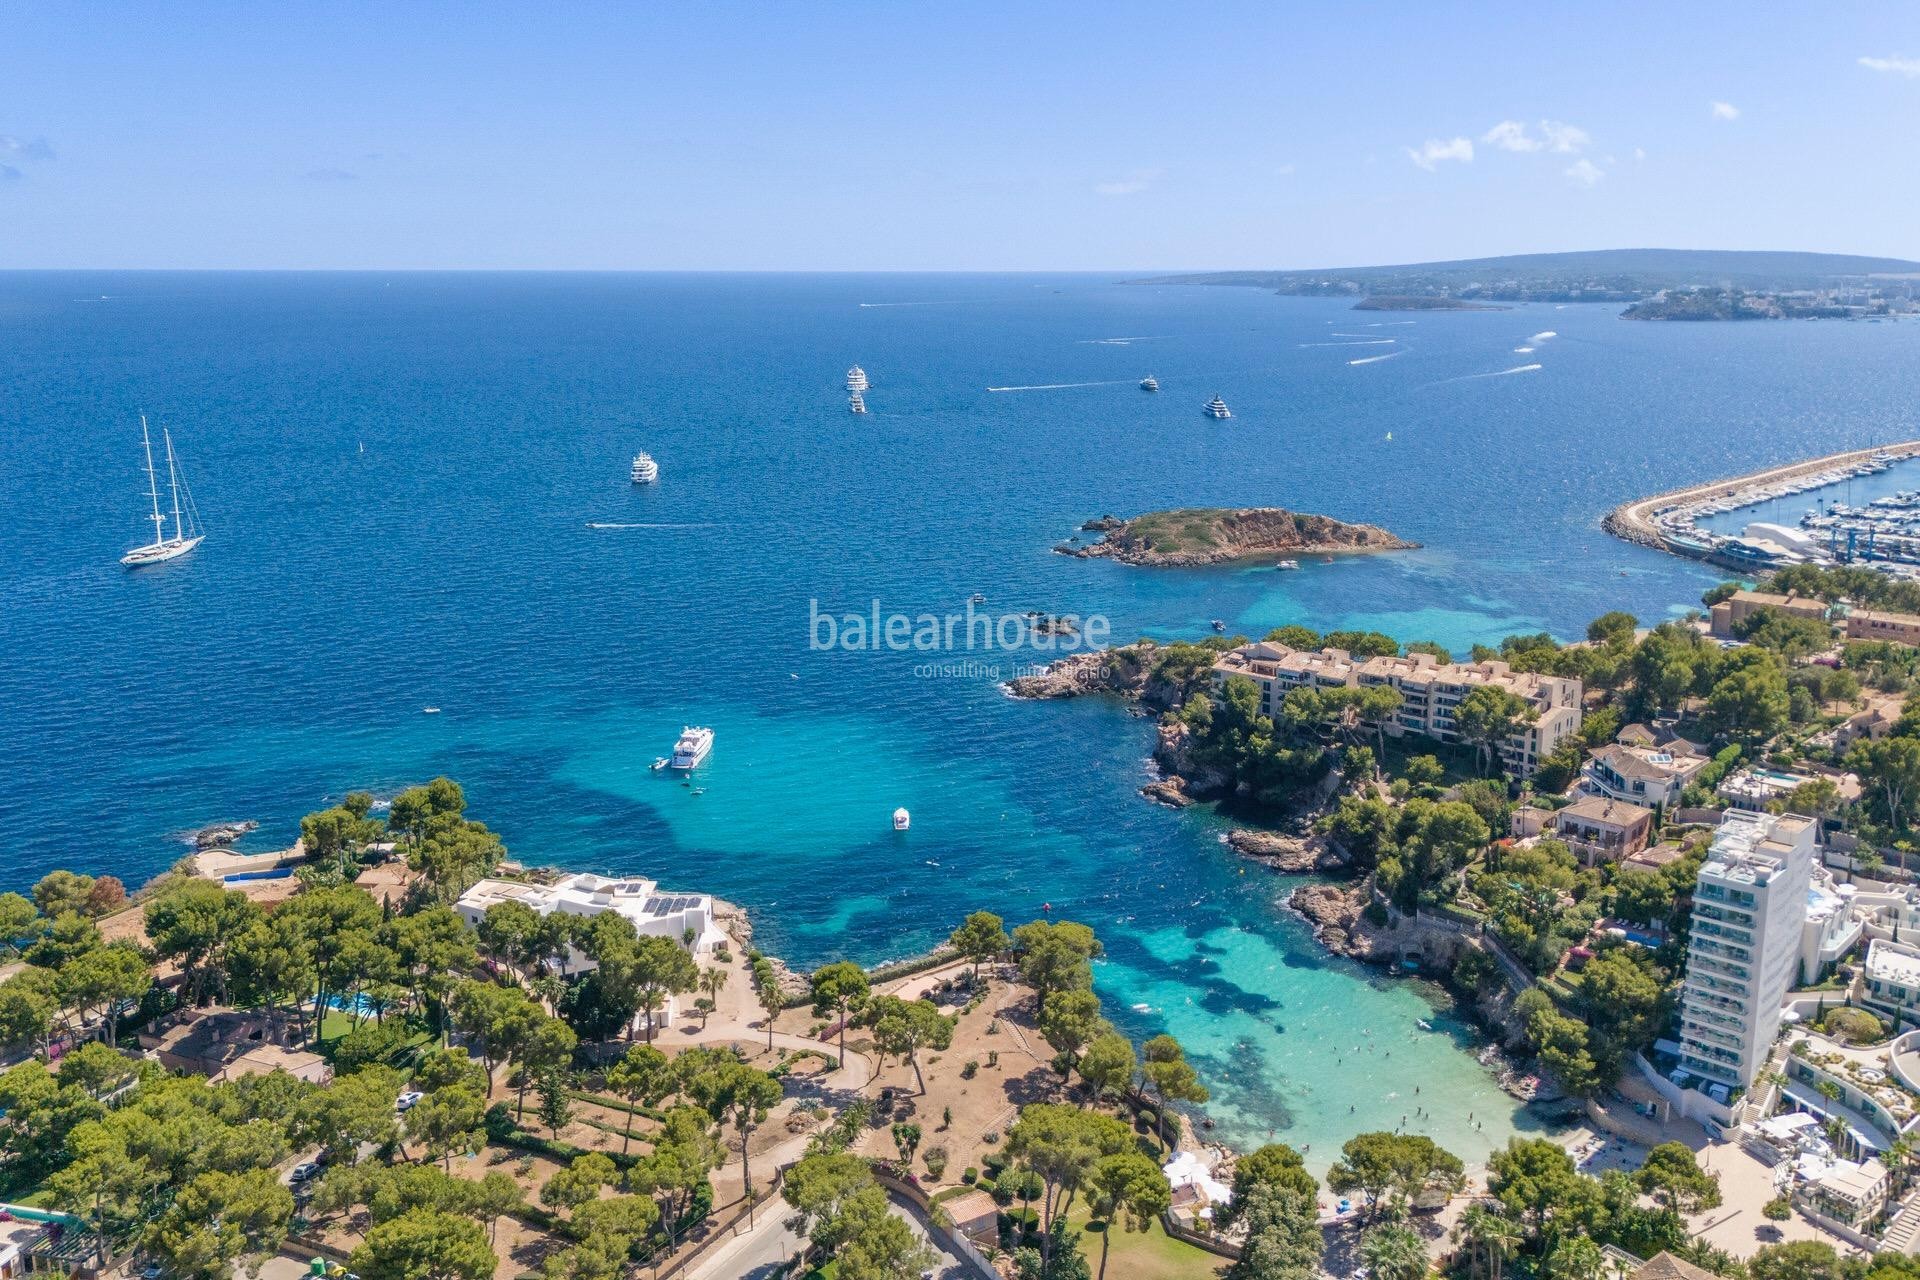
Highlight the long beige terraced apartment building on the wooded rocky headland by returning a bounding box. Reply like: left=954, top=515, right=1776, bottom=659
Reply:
left=1213, top=641, right=1580, bottom=775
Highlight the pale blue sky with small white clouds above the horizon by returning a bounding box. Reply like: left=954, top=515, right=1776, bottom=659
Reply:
left=0, top=0, right=1920, bottom=271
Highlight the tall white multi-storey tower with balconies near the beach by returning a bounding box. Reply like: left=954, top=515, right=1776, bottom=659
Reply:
left=1680, top=810, right=1814, bottom=1103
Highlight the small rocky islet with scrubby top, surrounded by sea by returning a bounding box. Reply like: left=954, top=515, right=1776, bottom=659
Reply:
left=1054, top=507, right=1419, bottom=568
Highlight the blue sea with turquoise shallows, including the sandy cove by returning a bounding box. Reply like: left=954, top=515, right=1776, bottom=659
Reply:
left=0, top=273, right=1920, bottom=1167
